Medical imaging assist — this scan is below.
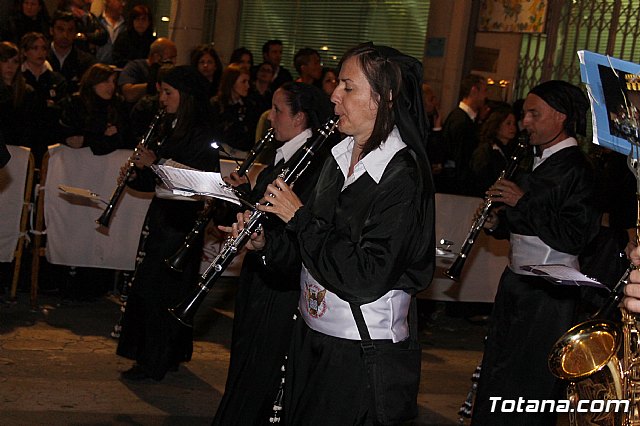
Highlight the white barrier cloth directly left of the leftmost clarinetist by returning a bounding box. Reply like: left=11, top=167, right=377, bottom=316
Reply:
left=44, top=145, right=154, bottom=270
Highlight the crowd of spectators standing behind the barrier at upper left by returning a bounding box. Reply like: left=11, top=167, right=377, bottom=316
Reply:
left=0, top=0, right=337, bottom=300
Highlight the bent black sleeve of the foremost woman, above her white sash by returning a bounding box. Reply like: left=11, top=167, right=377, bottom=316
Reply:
left=287, top=156, right=433, bottom=303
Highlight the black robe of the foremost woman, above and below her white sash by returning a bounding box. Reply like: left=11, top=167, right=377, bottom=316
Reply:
left=263, top=148, right=434, bottom=425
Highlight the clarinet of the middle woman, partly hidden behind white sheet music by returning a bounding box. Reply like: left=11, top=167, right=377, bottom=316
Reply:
left=165, top=128, right=275, bottom=272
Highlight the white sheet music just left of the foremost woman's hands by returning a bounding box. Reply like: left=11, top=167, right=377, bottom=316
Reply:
left=151, top=164, right=240, bottom=205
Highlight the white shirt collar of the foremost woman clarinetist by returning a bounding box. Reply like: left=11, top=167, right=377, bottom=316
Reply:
left=331, top=127, right=407, bottom=186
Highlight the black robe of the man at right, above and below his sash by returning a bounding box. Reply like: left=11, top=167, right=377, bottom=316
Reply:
left=472, top=147, right=600, bottom=426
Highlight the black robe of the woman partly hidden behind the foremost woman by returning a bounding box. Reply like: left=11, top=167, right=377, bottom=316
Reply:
left=213, top=131, right=333, bottom=426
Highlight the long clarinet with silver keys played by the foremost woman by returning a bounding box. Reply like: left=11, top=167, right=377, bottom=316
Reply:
left=169, top=116, right=340, bottom=327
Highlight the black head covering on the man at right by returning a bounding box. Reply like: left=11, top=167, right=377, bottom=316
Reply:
left=529, top=80, right=589, bottom=136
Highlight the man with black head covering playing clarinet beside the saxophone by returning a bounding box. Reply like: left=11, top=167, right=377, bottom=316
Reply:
left=472, top=80, right=600, bottom=426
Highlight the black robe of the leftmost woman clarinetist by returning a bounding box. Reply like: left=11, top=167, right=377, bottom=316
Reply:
left=116, top=121, right=220, bottom=380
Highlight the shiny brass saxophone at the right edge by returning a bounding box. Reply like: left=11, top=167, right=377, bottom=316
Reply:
left=548, top=143, right=640, bottom=426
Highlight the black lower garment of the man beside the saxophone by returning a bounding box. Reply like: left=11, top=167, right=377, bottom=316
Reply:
left=471, top=268, right=579, bottom=426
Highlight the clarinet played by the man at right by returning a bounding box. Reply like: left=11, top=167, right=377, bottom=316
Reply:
left=444, top=133, right=529, bottom=281
